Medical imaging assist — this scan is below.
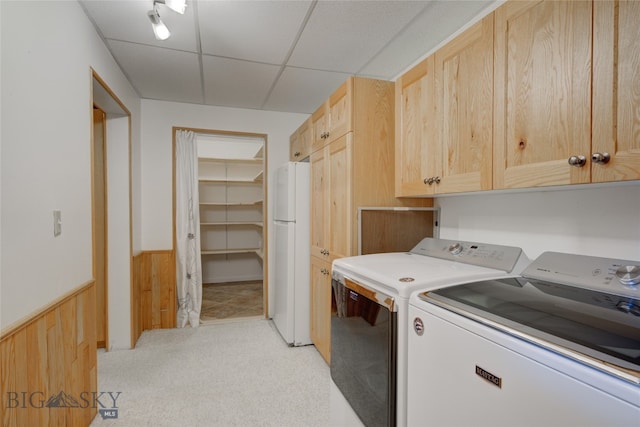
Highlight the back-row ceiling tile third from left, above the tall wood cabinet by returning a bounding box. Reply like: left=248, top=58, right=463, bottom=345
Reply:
left=264, top=67, right=350, bottom=114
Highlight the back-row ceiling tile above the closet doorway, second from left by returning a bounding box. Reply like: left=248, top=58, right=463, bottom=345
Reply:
left=202, top=55, right=280, bottom=109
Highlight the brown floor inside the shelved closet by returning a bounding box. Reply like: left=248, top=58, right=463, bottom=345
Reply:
left=200, top=280, right=264, bottom=321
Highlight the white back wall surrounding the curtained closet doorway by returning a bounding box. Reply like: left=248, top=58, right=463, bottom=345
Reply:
left=141, top=100, right=308, bottom=318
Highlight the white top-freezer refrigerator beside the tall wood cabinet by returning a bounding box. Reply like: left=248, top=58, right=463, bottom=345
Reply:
left=273, top=162, right=311, bottom=346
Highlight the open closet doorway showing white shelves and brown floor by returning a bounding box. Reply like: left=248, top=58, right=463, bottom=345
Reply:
left=174, top=129, right=268, bottom=323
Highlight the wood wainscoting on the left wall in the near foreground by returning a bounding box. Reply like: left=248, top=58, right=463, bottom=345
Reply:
left=0, top=281, right=98, bottom=427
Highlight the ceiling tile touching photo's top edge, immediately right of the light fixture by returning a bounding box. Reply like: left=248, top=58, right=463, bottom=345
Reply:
left=198, top=0, right=311, bottom=64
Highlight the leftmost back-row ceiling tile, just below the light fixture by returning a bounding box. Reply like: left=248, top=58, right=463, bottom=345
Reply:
left=109, top=40, right=203, bottom=104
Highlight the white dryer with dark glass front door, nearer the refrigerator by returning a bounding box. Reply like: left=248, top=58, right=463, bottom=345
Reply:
left=330, top=238, right=529, bottom=427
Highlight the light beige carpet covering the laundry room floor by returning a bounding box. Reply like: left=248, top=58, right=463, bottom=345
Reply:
left=91, top=319, right=330, bottom=427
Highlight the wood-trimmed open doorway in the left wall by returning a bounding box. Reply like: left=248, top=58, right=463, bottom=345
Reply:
left=90, top=69, right=135, bottom=351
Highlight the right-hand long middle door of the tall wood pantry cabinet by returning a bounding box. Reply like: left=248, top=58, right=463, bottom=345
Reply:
left=325, top=132, right=355, bottom=260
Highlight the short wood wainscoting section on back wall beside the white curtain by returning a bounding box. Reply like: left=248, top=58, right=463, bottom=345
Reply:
left=131, top=250, right=176, bottom=346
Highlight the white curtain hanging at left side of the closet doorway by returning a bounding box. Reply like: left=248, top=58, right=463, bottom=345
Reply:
left=176, top=130, right=202, bottom=328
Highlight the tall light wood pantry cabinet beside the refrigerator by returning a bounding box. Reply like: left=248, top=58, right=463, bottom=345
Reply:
left=310, top=77, right=431, bottom=362
